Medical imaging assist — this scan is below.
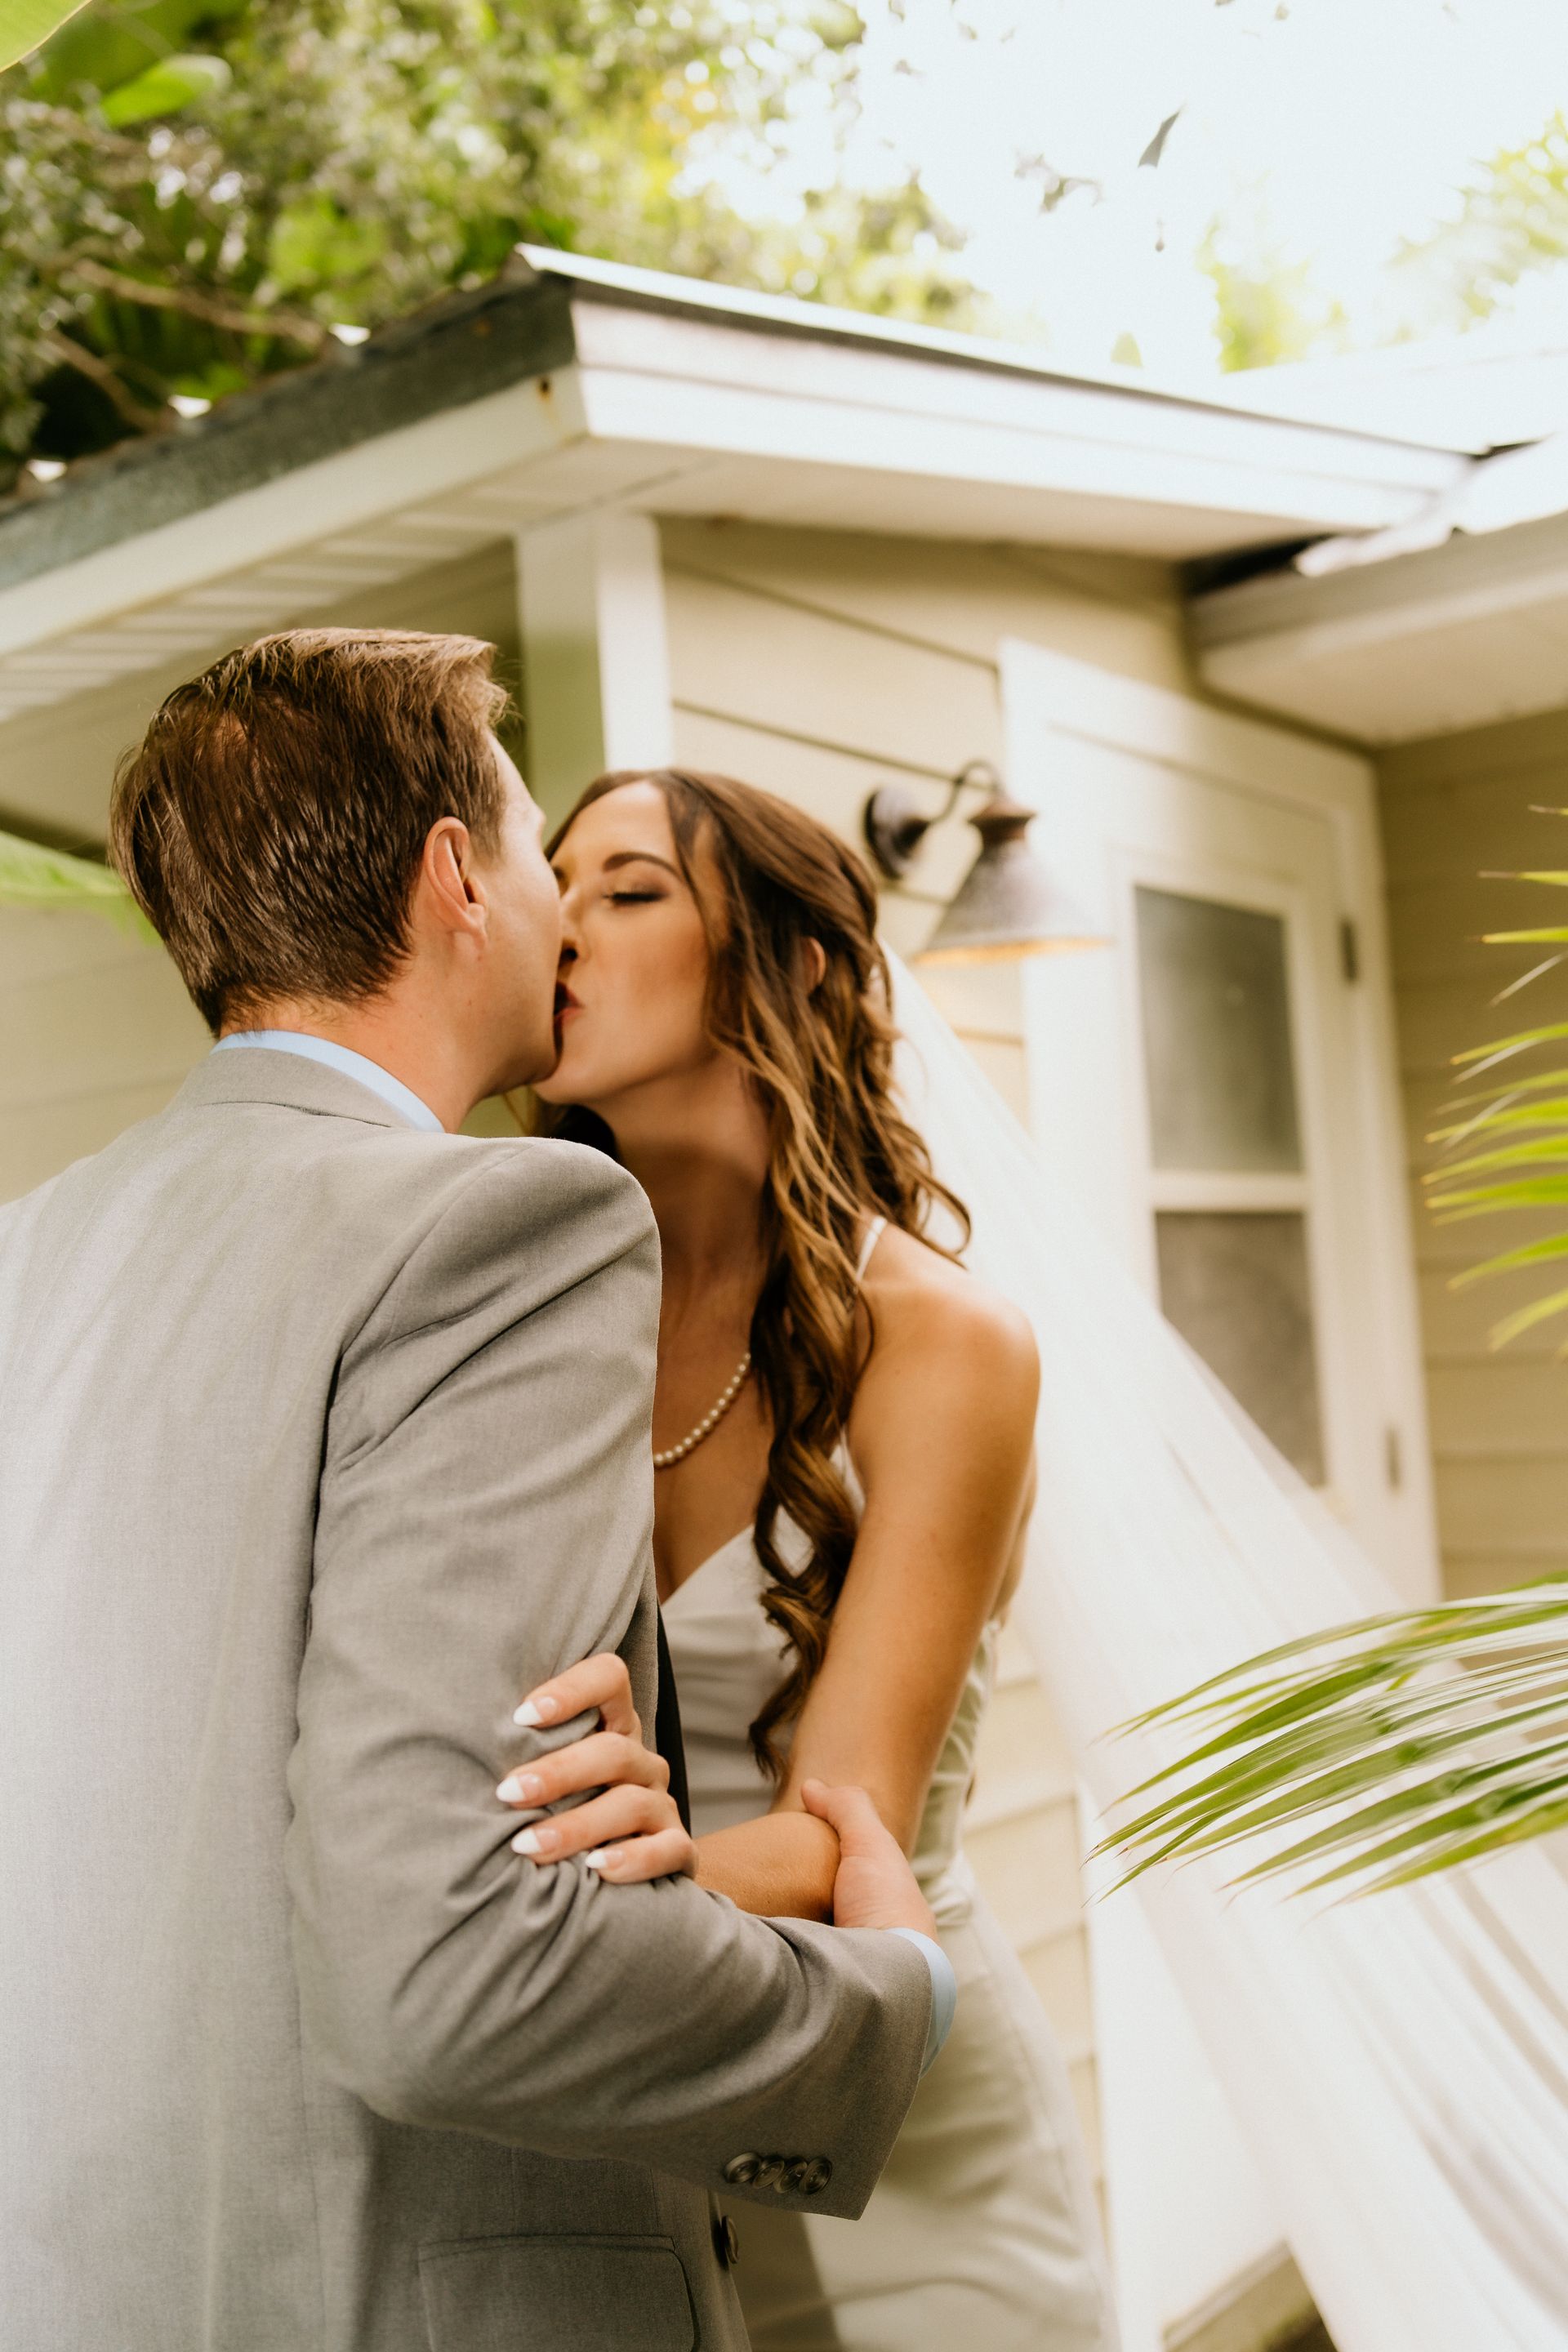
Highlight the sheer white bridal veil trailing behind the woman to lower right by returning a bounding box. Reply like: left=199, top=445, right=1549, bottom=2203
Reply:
left=896, top=967, right=1568, bottom=2352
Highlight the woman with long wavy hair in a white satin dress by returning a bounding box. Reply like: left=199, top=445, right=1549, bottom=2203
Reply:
left=503, top=769, right=1114, bottom=2352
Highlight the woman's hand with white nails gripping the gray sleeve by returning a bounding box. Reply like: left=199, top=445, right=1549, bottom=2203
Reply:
left=496, top=1651, right=696, bottom=1886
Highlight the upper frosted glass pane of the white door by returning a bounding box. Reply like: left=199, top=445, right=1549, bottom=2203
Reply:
left=1138, top=889, right=1303, bottom=1171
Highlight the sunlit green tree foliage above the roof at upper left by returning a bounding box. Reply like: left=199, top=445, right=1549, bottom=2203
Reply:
left=0, top=0, right=964, bottom=487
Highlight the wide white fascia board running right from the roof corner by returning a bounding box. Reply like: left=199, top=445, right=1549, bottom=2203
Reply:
left=573, top=301, right=1464, bottom=537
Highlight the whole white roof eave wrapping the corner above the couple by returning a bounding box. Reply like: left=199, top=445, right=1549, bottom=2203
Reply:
left=0, top=266, right=1464, bottom=719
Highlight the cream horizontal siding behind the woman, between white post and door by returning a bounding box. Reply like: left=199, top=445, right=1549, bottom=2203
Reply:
left=663, top=522, right=1190, bottom=2171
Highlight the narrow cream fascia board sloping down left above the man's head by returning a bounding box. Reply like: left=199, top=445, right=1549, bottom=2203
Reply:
left=0, top=367, right=586, bottom=654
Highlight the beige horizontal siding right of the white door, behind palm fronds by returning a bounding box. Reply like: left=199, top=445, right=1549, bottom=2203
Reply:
left=1380, top=710, right=1568, bottom=1592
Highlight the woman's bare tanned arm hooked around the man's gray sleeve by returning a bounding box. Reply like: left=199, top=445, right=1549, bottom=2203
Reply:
left=503, top=1260, right=1039, bottom=1919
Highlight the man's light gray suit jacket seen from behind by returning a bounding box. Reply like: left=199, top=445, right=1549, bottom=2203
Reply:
left=0, top=1049, right=931, bottom=2352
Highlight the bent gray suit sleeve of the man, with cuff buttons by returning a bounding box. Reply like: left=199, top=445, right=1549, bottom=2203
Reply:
left=287, top=1146, right=931, bottom=2216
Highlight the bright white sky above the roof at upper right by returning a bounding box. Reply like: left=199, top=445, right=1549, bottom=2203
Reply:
left=710, top=0, right=1568, bottom=376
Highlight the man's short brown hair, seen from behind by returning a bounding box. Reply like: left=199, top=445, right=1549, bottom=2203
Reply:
left=108, top=628, right=508, bottom=1032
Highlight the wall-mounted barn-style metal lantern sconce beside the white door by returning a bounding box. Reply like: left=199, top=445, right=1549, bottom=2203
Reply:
left=862, top=760, right=1110, bottom=964
